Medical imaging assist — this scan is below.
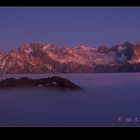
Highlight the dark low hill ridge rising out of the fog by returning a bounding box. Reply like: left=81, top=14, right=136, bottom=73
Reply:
left=0, top=76, right=81, bottom=90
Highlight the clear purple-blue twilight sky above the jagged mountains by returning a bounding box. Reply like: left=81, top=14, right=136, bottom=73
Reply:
left=0, top=7, right=140, bottom=50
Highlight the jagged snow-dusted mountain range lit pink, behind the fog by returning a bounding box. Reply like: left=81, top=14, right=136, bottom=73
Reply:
left=0, top=41, right=140, bottom=74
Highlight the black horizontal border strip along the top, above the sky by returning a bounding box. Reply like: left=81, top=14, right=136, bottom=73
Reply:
left=0, top=0, right=140, bottom=7
